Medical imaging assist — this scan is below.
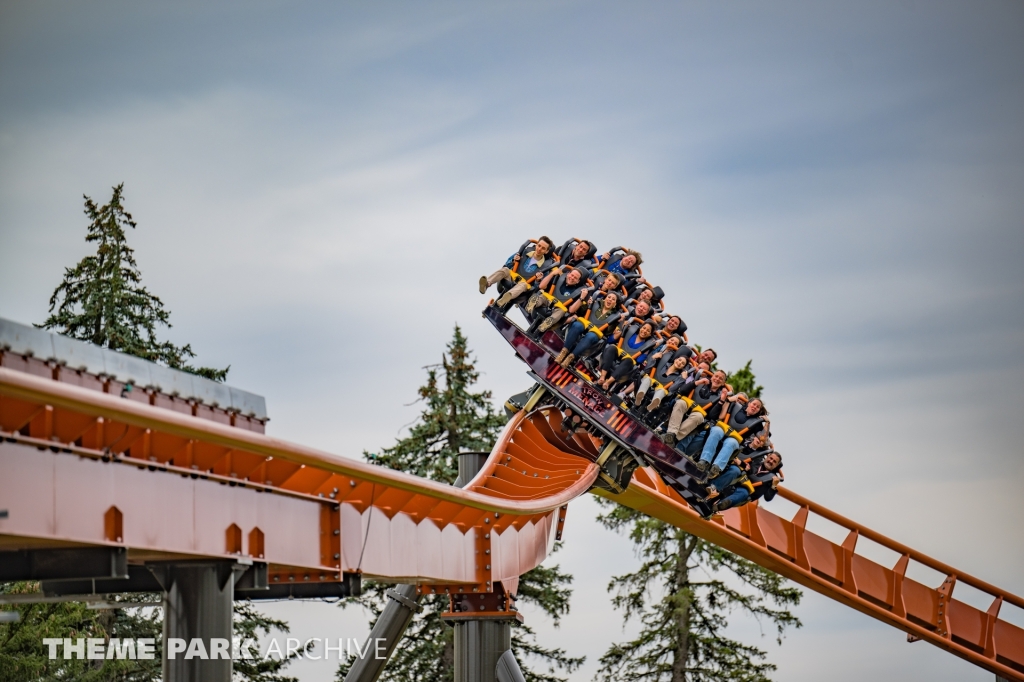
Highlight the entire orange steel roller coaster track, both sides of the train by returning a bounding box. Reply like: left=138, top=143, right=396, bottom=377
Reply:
left=0, top=368, right=1024, bottom=682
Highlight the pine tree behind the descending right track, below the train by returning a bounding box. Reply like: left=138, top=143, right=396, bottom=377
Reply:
left=598, top=361, right=801, bottom=682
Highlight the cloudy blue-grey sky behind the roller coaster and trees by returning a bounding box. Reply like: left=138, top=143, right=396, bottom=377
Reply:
left=0, top=0, right=1024, bottom=682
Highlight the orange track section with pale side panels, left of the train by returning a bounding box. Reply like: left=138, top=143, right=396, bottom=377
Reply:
left=0, top=368, right=598, bottom=589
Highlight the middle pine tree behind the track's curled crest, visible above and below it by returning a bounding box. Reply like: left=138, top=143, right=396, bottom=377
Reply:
left=337, top=326, right=583, bottom=682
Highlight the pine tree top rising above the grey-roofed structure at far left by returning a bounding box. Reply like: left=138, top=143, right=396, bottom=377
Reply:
left=42, top=183, right=230, bottom=381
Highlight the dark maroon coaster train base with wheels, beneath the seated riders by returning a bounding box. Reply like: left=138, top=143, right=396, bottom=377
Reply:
left=483, top=305, right=713, bottom=518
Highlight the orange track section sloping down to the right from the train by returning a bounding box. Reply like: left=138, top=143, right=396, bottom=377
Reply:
left=595, top=468, right=1024, bottom=680
